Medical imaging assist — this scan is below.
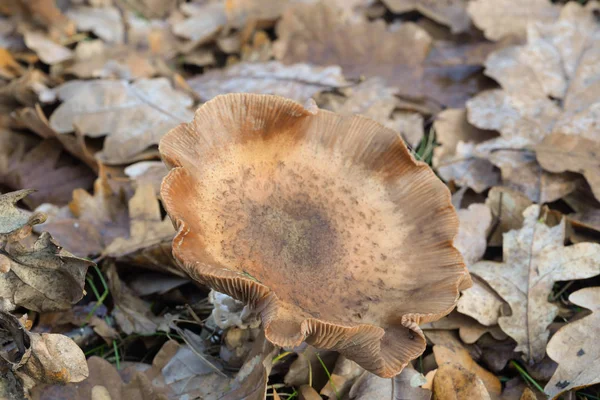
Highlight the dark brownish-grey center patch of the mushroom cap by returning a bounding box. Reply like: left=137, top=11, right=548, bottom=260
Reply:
left=243, top=196, right=337, bottom=269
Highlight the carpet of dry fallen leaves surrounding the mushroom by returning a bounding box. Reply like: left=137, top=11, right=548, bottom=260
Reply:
left=0, top=0, right=600, bottom=400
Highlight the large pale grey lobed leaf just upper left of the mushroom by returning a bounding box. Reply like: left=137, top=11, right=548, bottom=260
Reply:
left=50, top=78, right=193, bottom=164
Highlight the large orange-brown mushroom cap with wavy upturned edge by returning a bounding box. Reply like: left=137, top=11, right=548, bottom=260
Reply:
left=160, top=94, right=471, bottom=377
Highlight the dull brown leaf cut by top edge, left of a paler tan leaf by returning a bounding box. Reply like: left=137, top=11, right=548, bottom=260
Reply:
left=383, top=0, right=471, bottom=33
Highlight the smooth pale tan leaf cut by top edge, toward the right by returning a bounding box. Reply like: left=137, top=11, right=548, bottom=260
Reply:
left=467, top=0, right=560, bottom=40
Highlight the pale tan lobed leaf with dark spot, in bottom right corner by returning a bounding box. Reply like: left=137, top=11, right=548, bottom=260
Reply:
left=544, top=287, right=600, bottom=399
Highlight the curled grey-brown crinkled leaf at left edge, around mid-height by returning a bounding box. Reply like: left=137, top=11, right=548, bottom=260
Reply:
left=0, top=190, right=93, bottom=311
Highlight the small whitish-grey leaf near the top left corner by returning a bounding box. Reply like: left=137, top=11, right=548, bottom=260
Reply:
left=67, top=6, right=125, bottom=43
